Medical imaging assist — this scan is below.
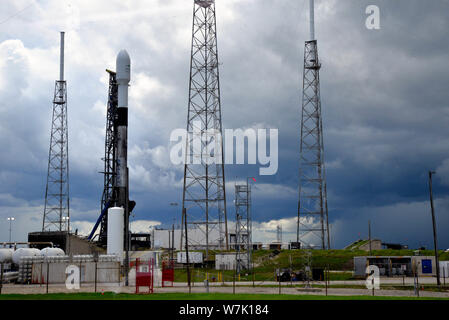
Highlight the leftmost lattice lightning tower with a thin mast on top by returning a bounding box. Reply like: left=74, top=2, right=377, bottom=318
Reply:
left=42, top=32, right=70, bottom=231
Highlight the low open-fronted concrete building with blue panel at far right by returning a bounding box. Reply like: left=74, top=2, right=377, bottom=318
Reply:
left=354, top=256, right=436, bottom=277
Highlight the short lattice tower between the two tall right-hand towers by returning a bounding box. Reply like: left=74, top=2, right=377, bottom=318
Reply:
left=235, top=181, right=252, bottom=273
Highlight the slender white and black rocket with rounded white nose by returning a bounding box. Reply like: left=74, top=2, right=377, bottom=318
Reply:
left=116, top=50, right=131, bottom=212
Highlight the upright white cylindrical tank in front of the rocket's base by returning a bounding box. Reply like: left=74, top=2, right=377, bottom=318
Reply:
left=107, top=208, right=125, bottom=262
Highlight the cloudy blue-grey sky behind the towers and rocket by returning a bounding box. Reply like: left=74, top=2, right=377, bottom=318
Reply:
left=0, top=0, right=449, bottom=248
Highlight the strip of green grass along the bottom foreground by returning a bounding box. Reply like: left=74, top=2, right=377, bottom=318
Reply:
left=0, top=292, right=449, bottom=301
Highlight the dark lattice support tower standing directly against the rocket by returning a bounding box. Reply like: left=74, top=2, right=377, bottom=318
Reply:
left=98, top=70, right=118, bottom=244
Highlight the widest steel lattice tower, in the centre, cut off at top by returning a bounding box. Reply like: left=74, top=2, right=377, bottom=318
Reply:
left=181, top=0, right=229, bottom=257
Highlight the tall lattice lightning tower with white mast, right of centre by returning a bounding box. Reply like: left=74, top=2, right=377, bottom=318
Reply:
left=297, top=0, right=330, bottom=249
